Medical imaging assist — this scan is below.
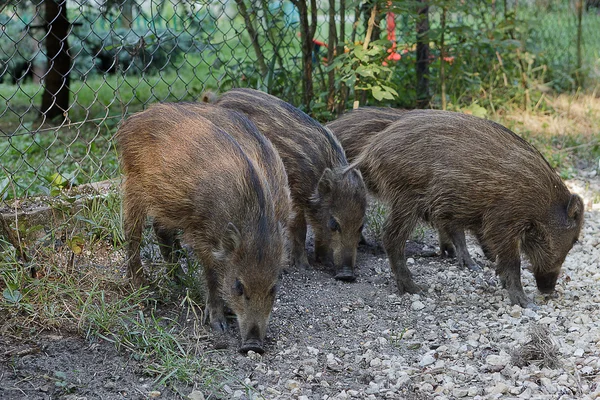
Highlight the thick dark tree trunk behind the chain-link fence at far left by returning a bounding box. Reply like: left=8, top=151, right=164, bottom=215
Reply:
left=40, top=0, right=71, bottom=119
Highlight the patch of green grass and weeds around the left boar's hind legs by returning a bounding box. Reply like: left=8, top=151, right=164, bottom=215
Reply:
left=0, top=193, right=234, bottom=391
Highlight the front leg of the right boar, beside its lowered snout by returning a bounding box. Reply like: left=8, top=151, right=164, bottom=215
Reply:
left=496, top=244, right=537, bottom=308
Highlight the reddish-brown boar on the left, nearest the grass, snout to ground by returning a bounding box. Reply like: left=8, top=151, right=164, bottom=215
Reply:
left=116, top=104, right=285, bottom=352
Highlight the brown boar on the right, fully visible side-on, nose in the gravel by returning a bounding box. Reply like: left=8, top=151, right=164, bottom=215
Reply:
left=350, top=110, right=584, bottom=307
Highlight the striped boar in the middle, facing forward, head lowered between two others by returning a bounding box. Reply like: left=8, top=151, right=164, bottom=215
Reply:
left=216, top=89, right=367, bottom=281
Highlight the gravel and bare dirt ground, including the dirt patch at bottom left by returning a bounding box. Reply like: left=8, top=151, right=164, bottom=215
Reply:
left=0, top=173, right=600, bottom=400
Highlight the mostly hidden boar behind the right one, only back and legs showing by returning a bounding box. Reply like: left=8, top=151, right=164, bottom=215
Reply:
left=326, top=107, right=493, bottom=270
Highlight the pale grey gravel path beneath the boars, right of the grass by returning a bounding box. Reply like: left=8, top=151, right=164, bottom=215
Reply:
left=200, top=173, right=600, bottom=400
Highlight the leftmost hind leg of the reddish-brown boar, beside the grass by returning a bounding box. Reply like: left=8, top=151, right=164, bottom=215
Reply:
left=123, top=186, right=146, bottom=287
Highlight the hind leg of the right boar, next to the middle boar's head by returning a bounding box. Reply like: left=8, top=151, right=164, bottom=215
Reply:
left=383, top=207, right=421, bottom=294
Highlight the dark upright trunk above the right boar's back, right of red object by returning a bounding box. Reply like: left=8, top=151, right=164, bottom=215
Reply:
left=416, top=0, right=429, bottom=108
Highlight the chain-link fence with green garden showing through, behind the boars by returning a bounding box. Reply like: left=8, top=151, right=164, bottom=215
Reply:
left=0, top=0, right=600, bottom=208
